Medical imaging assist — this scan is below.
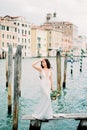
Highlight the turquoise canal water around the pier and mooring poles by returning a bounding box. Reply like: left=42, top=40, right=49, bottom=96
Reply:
left=0, top=58, right=87, bottom=130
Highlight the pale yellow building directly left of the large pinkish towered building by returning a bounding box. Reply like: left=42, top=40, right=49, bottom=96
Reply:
left=41, top=25, right=62, bottom=56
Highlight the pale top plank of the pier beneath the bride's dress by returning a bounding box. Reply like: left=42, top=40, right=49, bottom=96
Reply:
left=22, top=113, right=87, bottom=120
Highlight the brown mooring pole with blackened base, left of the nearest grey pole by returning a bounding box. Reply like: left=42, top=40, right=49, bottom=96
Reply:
left=8, top=45, right=13, bottom=114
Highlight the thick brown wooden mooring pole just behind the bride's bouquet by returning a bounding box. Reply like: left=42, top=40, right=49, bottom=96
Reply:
left=56, top=51, right=61, bottom=93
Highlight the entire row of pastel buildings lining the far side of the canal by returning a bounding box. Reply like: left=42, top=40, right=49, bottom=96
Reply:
left=0, top=13, right=87, bottom=58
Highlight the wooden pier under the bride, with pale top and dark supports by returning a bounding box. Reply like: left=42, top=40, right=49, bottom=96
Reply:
left=22, top=113, right=87, bottom=130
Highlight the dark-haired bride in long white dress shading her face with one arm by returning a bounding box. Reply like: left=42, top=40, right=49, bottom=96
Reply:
left=32, top=59, right=54, bottom=119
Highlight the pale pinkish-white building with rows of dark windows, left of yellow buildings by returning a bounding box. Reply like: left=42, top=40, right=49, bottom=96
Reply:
left=12, top=16, right=31, bottom=58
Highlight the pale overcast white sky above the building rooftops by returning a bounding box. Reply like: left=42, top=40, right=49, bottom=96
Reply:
left=0, top=0, right=87, bottom=36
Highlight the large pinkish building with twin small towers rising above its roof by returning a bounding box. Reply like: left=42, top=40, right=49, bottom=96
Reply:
left=42, top=13, right=78, bottom=52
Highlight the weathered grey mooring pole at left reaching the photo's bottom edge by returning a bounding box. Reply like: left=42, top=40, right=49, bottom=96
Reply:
left=12, top=45, right=22, bottom=130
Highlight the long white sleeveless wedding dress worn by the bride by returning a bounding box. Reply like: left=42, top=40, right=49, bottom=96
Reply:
left=32, top=69, right=53, bottom=119
